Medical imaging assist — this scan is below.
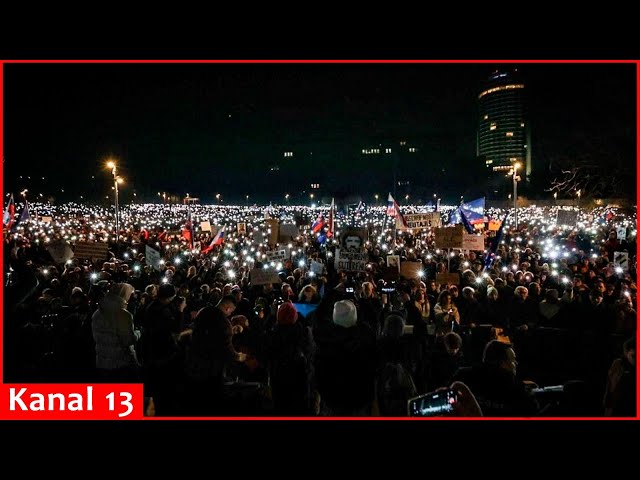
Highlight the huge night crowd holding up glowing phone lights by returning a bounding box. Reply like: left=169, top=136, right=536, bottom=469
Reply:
left=3, top=199, right=637, bottom=417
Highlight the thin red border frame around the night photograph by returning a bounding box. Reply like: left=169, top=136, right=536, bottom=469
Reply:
left=0, top=59, right=640, bottom=421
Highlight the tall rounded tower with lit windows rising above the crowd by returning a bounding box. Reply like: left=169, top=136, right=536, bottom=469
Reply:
left=477, top=70, right=532, bottom=181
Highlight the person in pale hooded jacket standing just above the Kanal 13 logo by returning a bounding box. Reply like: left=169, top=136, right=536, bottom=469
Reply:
left=91, top=283, right=140, bottom=382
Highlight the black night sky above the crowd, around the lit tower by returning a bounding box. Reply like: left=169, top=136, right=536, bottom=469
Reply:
left=4, top=64, right=636, bottom=201
